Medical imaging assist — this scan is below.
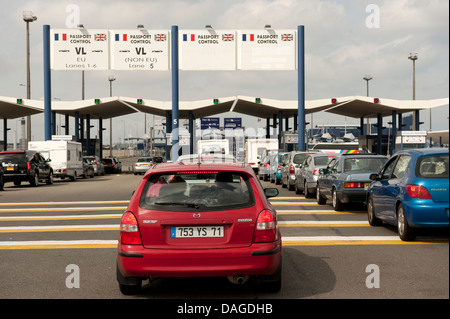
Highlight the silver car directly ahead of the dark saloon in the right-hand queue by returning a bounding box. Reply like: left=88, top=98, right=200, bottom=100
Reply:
left=294, top=153, right=336, bottom=198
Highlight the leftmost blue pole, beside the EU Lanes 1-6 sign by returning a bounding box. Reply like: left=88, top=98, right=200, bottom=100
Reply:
left=43, top=25, right=52, bottom=141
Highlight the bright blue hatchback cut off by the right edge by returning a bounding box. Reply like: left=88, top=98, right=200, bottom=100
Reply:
left=367, top=148, right=449, bottom=241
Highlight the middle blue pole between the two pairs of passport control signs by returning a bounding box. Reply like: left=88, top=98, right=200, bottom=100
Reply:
left=171, top=26, right=180, bottom=162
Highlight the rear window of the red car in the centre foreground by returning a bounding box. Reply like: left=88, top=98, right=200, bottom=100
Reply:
left=139, top=171, right=255, bottom=212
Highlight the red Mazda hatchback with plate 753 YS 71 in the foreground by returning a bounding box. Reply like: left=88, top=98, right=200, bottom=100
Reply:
left=117, top=162, right=281, bottom=294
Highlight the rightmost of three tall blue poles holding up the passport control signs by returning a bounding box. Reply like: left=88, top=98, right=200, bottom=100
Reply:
left=297, top=25, right=305, bottom=151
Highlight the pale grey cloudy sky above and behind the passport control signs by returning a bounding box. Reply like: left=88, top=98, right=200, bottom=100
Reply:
left=0, top=0, right=449, bottom=143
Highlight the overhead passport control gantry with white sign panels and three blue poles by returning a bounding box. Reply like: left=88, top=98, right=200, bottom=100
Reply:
left=44, top=25, right=305, bottom=157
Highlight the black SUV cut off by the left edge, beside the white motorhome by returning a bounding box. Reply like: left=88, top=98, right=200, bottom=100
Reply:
left=0, top=151, right=53, bottom=186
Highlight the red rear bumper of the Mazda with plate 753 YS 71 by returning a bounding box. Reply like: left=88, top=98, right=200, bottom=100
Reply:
left=117, top=242, right=281, bottom=277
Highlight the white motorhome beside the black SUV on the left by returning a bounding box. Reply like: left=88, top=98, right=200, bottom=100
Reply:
left=28, top=141, right=84, bottom=181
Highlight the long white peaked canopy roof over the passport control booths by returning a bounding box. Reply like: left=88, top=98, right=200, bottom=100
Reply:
left=0, top=95, right=449, bottom=119
